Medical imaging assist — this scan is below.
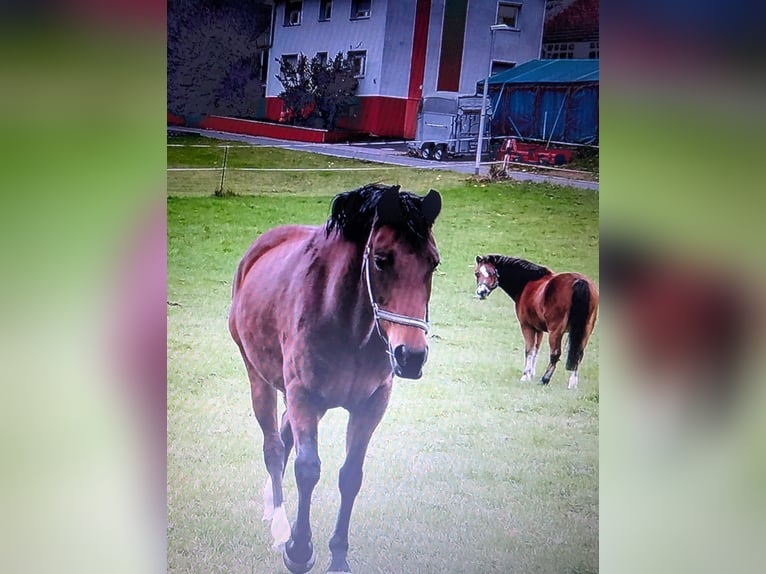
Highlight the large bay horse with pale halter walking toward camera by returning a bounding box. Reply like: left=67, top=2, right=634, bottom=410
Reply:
left=229, top=184, right=441, bottom=574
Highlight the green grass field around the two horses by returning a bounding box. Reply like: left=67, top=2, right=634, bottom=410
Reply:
left=167, top=140, right=599, bottom=574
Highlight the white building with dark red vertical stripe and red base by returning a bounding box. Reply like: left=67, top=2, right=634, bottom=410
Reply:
left=266, top=0, right=545, bottom=138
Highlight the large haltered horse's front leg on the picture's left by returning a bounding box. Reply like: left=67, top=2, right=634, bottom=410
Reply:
left=282, top=388, right=324, bottom=574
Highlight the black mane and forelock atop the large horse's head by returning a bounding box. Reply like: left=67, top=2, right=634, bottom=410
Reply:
left=325, top=183, right=430, bottom=244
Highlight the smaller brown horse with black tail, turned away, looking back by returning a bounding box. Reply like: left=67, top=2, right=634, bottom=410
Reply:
left=474, top=255, right=598, bottom=389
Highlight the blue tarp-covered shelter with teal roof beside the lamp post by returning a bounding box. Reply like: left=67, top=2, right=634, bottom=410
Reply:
left=478, top=59, right=599, bottom=145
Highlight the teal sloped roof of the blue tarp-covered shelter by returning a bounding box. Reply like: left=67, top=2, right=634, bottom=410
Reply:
left=486, top=59, right=599, bottom=85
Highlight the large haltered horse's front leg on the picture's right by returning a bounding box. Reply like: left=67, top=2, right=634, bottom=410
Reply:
left=329, top=382, right=391, bottom=572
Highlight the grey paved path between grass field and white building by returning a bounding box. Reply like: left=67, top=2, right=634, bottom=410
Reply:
left=168, top=126, right=598, bottom=191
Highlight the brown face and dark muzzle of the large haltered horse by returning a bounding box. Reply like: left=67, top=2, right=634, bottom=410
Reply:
left=370, top=227, right=438, bottom=379
